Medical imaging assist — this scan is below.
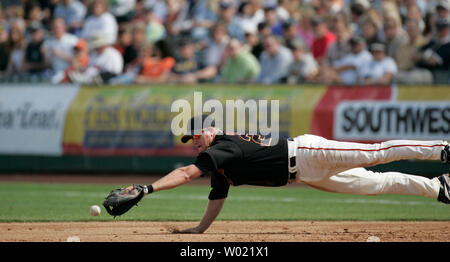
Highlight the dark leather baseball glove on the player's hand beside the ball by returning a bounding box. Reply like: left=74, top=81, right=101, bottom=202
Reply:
left=103, top=184, right=148, bottom=217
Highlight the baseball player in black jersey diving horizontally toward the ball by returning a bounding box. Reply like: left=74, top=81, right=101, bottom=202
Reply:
left=114, top=115, right=450, bottom=233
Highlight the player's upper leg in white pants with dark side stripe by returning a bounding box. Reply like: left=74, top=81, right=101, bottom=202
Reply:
left=295, top=135, right=447, bottom=182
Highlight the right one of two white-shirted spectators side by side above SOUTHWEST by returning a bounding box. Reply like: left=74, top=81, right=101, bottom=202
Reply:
left=359, top=43, right=397, bottom=85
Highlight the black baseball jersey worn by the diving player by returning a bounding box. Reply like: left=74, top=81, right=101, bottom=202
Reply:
left=194, top=135, right=289, bottom=200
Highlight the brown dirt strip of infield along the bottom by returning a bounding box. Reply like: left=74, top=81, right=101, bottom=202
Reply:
left=0, top=221, right=450, bottom=242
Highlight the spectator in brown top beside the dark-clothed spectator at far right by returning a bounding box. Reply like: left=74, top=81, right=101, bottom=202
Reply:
left=393, top=19, right=433, bottom=84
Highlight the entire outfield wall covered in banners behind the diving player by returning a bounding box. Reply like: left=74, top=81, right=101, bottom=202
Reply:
left=0, top=85, right=450, bottom=175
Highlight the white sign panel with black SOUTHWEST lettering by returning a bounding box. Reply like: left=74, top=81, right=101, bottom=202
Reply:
left=334, top=101, right=450, bottom=140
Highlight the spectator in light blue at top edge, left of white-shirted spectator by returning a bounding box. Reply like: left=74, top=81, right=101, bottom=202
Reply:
left=53, top=0, right=87, bottom=35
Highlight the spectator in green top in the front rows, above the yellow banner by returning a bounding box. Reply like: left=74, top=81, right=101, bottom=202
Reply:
left=220, top=38, right=261, bottom=84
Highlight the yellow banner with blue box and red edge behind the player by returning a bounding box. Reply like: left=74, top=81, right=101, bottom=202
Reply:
left=64, top=86, right=326, bottom=156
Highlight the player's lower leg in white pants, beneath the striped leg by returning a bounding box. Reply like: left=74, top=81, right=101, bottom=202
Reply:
left=298, top=168, right=441, bottom=198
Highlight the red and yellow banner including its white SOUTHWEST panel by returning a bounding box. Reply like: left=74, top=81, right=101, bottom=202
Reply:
left=311, top=86, right=450, bottom=142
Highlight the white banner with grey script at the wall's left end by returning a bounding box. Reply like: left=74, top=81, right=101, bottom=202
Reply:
left=0, top=85, right=78, bottom=156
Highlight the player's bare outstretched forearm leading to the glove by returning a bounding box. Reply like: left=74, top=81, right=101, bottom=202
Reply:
left=148, top=165, right=202, bottom=192
